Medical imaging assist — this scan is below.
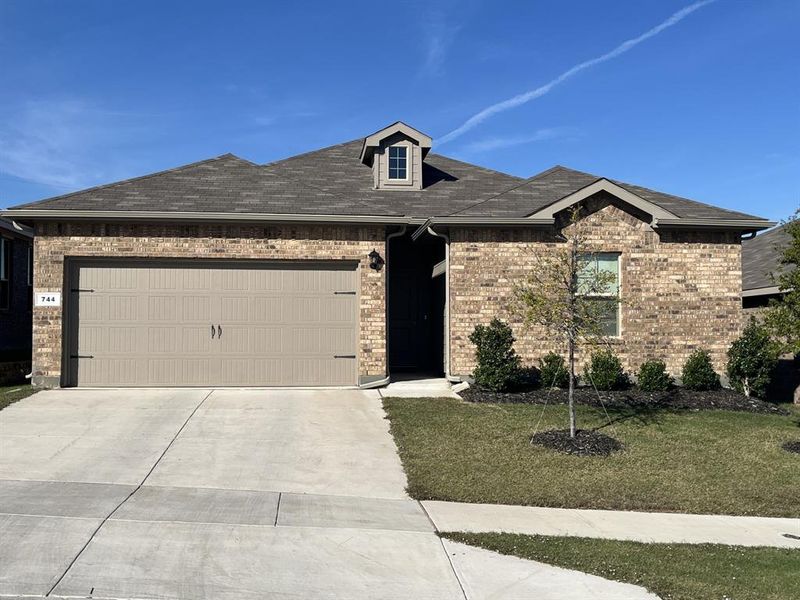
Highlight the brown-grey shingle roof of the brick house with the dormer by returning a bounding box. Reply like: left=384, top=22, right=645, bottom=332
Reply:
left=7, top=139, right=768, bottom=225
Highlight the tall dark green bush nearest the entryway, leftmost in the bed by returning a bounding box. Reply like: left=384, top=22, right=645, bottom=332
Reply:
left=469, top=319, right=520, bottom=392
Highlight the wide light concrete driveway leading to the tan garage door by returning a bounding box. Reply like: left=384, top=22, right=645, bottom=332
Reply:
left=0, top=389, right=650, bottom=600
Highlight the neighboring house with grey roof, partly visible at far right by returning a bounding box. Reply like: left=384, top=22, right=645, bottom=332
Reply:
left=742, top=225, right=789, bottom=314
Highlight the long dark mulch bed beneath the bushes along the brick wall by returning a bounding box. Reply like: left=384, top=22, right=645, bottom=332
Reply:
left=460, top=386, right=789, bottom=415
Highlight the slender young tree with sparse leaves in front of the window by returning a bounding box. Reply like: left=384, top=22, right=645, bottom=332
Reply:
left=511, top=208, right=619, bottom=437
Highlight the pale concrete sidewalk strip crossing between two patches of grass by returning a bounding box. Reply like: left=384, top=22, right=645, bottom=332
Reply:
left=422, top=501, right=800, bottom=549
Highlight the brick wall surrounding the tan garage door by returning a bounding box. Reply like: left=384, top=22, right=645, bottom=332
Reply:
left=33, top=223, right=386, bottom=386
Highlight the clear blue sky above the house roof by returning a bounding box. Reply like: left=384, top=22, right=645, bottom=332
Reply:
left=0, top=0, right=800, bottom=220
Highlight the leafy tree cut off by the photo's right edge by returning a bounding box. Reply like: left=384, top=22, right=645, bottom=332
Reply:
left=764, top=210, right=800, bottom=354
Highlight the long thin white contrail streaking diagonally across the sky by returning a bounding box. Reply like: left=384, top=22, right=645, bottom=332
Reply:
left=437, top=0, right=716, bottom=145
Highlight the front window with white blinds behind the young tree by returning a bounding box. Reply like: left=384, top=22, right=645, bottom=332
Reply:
left=578, top=252, right=620, bottom=337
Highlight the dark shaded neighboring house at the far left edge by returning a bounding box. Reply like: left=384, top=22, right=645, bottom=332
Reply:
left=0, top=219, right=33, bottom=385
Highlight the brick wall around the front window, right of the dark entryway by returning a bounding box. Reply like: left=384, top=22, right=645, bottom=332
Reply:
left=450, top=198, right=741, bottom=375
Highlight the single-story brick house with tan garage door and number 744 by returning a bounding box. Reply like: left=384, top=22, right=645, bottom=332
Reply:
left=5, top=122, right=772, bottom=386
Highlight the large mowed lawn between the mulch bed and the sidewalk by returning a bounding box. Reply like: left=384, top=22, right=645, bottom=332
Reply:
left=384, top=398, right=800, bottom=517
